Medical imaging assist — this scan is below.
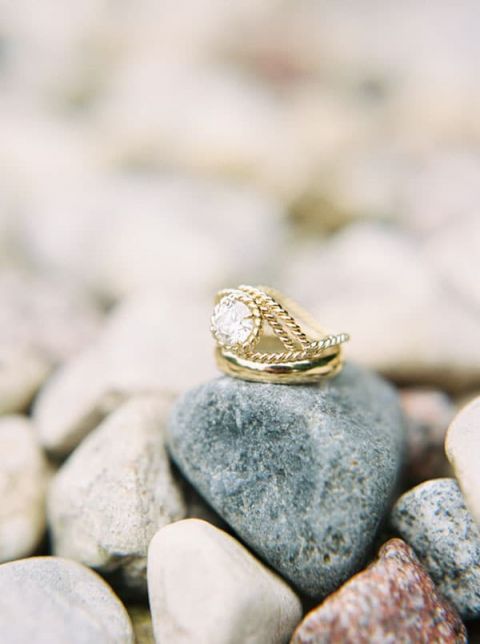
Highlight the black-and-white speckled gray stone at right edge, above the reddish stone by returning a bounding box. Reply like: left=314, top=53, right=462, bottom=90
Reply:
left=391, top=479, right=480, bottom=619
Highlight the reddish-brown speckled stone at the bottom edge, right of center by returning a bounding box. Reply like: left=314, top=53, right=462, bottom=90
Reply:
left=291, top=539, right=467, bottom=644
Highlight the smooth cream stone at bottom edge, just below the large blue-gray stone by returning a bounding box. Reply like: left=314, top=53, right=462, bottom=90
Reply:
left=148, top=519, right=302, bottom=644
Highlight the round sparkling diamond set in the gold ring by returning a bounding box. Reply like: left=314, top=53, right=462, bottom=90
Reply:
left=212, top=295, right=255, bottom=346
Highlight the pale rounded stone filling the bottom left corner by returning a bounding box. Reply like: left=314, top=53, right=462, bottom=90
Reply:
left=0, top=557, right=134, bottom=644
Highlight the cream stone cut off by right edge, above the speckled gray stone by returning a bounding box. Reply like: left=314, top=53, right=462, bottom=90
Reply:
left=445, top=396, right=480, bottom=525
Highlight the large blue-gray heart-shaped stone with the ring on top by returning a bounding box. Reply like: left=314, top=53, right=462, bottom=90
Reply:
left=168, top=365, right=404, bottom=597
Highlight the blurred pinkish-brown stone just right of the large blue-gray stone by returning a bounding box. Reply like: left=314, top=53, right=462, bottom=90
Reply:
left=400, top=388, right=455, bottom=487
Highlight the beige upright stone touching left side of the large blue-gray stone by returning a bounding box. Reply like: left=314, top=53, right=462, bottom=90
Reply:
left=48, top=396, right=185, bottom=593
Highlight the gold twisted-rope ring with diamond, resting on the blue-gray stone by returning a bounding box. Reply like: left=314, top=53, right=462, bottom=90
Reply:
left=211, top=285, right=349, bottom=383
